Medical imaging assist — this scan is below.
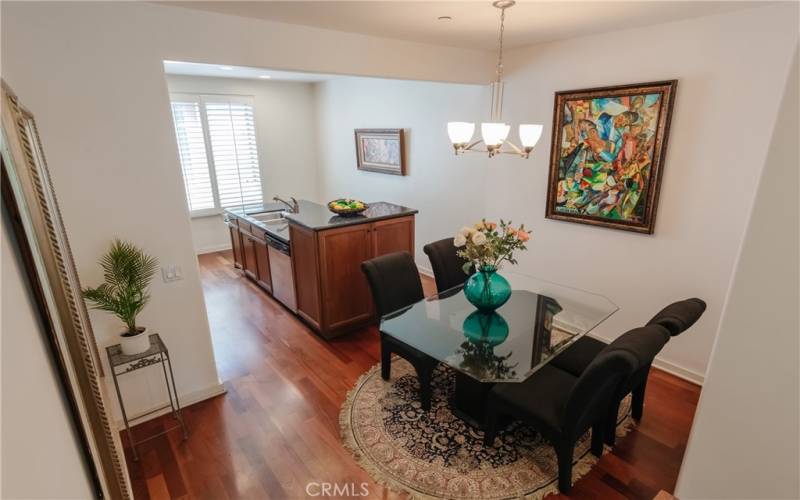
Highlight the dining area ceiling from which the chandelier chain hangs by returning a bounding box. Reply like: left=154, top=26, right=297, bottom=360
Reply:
left=160, top=0, right=772, bottom=50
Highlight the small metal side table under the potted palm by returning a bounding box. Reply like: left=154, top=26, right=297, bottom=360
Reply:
left=106, top=333, right=189, bottom=460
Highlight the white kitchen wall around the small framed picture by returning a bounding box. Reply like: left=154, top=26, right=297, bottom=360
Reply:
left=317, top=78, right=490, bottom=268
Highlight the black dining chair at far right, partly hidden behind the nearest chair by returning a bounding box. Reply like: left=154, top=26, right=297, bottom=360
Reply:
left=551, top=298, right=706, bottom=445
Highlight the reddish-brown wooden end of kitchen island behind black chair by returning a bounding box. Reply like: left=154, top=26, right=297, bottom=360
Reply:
left=290, top=216, right=414, bottom=338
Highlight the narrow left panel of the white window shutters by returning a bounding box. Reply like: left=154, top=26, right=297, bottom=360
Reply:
left=172, top=99, right=215, bottom=212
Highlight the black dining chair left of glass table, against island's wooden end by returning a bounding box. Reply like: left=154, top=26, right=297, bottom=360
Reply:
left=361, top=252, right=438, bottom=411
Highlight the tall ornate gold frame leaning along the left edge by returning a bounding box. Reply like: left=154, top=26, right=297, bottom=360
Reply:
left=0, top=81, right=132, bottom=499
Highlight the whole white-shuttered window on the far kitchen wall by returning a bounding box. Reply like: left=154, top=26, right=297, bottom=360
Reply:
left=171, top=94, right=263, bottom=215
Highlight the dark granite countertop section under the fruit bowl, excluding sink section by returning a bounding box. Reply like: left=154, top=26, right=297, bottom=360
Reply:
left=286, top=201, right=418, bottom=231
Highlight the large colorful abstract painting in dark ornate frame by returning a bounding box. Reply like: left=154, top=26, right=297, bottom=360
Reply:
left=547, top=80, right=677, bottom=233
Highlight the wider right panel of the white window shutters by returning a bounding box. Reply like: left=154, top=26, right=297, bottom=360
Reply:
left=204, top=96, right=263, bottom=208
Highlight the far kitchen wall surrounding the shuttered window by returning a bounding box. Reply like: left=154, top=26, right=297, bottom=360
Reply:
left=167, top=75, right=318, bottom=253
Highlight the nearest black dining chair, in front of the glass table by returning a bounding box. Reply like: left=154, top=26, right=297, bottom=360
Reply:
left=484, top=346, right=636, bottom=493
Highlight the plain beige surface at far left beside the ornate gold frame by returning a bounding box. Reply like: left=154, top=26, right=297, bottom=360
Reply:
left=0, top=217, right=93, bottom=499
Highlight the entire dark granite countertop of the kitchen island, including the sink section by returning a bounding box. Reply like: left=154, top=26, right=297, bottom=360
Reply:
left=225, top=200, right=418, bottom=243
